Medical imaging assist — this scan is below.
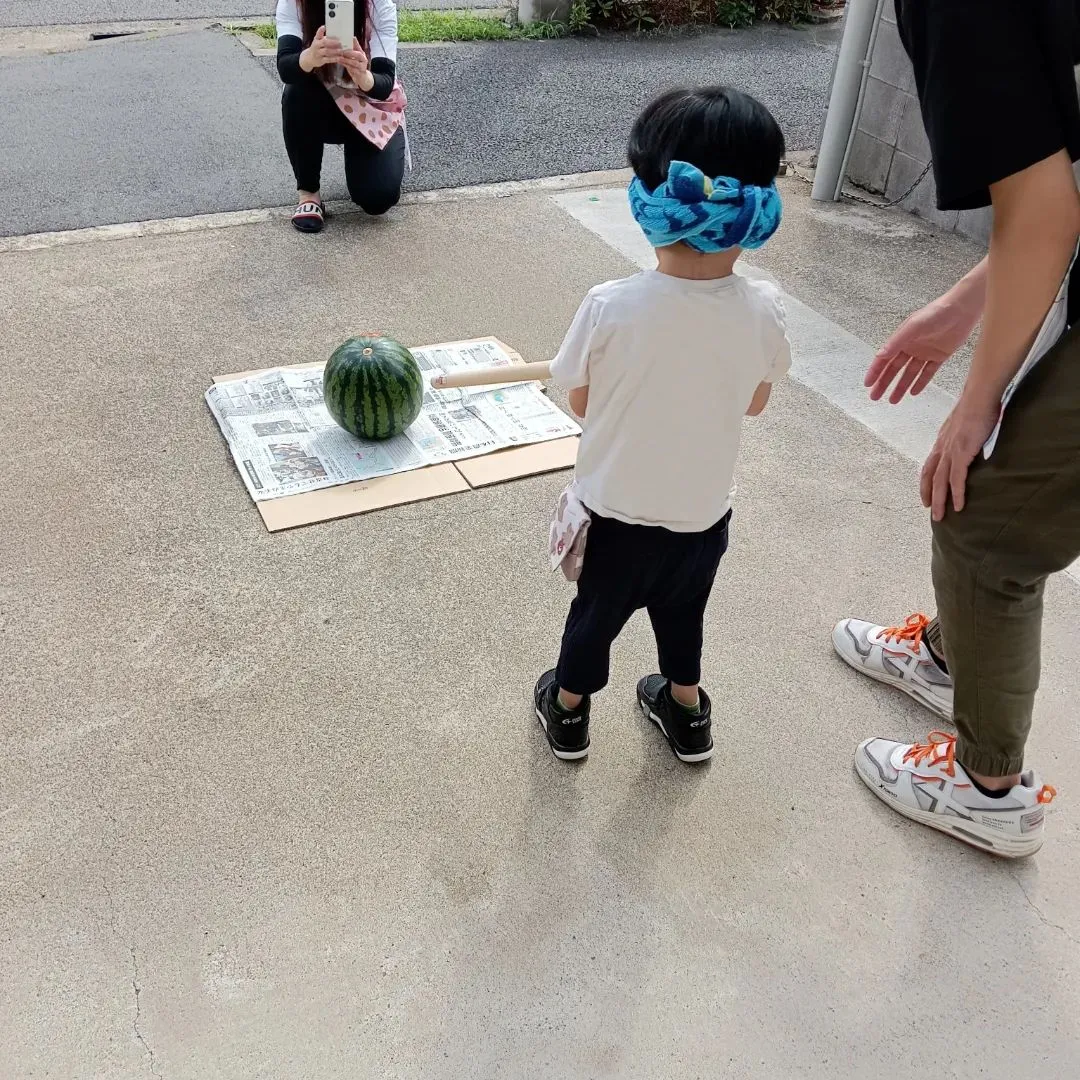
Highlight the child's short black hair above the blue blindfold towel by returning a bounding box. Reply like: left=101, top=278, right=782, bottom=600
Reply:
left=627, top=86, right=784, bottom=191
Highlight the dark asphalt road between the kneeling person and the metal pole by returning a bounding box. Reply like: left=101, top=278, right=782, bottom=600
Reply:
left=386, top=27, right=839, bottom=188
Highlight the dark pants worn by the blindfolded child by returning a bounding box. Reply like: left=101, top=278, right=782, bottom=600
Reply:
left=556, top=511, right=731, bottom=693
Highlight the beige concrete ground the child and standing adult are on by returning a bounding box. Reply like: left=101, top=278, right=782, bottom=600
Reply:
left=0, top=180, right=1080, bottom=1080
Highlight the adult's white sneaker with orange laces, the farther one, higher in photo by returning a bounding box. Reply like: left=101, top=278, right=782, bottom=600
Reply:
left=833, top=615, right=953, bottom=720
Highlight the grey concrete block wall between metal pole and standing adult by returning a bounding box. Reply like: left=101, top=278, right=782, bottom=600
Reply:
left=848, top=0, right=990, bottom=243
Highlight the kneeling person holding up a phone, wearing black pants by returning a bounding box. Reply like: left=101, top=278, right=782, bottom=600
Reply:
left=276, top=0, right=407, bottom=232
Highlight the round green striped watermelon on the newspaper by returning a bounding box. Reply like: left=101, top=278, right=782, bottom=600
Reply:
left=323, top=337, right=423, bottom=438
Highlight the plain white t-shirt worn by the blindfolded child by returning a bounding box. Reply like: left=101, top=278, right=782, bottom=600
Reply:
left=551, top=270, right=792, bottom=532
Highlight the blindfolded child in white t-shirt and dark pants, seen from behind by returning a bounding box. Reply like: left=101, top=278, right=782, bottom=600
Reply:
left=534, top=86, right=791, bottom=761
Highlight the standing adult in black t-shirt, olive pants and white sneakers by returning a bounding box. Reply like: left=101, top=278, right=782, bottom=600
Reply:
left=834, top=0, right=1080, bottom=856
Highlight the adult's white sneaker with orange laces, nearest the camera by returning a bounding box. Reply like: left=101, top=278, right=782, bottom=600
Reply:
left=855, top=731, right=1057, bottom=859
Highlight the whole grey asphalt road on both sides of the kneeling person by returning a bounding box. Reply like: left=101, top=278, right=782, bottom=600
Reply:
left=0, top=27, right=837, bottom=235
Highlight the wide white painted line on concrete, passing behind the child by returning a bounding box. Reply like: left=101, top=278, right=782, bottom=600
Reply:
left=552, top=188, right=1080, bottom=582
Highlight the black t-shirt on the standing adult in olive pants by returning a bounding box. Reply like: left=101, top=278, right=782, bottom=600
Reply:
left=895, top=0, right=1080, bottom=210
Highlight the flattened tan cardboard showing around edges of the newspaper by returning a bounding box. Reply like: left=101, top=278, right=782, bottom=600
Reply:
left=214, top=338, right=578, bottom=532
